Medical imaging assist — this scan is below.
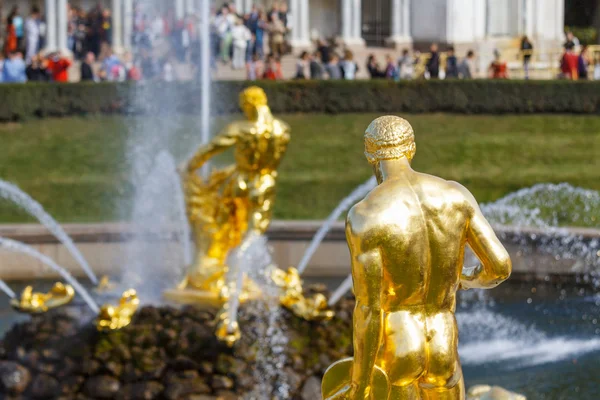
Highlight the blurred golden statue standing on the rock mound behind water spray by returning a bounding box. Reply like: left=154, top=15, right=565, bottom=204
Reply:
left=181, top=87, right=290, bottom=297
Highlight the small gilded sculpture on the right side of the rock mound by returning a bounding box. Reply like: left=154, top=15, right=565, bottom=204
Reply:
left=271, top=267, right=335, bottom=321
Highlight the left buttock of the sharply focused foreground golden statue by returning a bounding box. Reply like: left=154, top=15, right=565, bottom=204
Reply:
left=378, top=311, right=427, bottom=386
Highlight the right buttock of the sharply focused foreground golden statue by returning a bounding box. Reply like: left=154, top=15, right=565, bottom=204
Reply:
left=421, top=311, right=462, bottom=388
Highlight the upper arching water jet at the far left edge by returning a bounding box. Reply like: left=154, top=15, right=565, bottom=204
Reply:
left=0, top=179, right=98, bottom=285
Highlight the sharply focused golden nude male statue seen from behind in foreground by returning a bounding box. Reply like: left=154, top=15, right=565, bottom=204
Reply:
left=322, top=116, right=511, bottom=400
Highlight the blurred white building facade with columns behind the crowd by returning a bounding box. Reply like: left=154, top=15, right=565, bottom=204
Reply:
left=3, top=0, right=565, bottom=49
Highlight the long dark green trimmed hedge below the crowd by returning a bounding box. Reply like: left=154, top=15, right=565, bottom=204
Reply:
left=0, top=80, right=600, bottom=121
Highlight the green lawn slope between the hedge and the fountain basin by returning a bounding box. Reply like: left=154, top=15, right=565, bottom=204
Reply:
left=0, top=114, right=600, bottom=223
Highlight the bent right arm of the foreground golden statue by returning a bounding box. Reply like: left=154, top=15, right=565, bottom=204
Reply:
left=454, top=186, right=512, bottom=289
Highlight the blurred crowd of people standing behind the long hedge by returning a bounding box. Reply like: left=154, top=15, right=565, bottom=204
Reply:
left=0, top=1, right=600, bottom=83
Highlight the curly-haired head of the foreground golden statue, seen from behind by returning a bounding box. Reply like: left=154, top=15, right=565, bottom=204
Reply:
left=365, top=115, right=417, bottom=165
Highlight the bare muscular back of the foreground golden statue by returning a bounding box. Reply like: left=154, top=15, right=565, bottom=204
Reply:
left=349, top=171, right=470, bottom=312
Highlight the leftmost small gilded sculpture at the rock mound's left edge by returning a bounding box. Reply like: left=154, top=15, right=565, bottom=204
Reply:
left=10, top=282, right=75, bottom=314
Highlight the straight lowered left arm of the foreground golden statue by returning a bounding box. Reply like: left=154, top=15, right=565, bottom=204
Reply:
left=346, top=210, right=383, bottom=398
